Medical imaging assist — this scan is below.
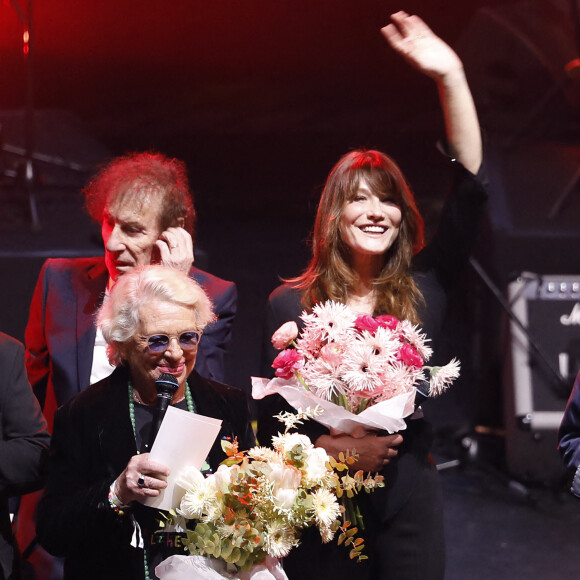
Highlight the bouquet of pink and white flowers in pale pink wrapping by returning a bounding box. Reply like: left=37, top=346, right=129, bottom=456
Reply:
left=252, top=301, right=459, bottom=433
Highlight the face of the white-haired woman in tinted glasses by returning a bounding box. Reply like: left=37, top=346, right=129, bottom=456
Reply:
left=121, top=300, right=198, bottom=400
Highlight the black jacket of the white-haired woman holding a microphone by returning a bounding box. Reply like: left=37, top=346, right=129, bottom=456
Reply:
left=37, top=368, right=254, bottom=580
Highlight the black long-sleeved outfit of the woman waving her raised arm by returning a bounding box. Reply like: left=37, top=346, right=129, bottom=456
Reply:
left=257, top=159, right=487, bottom=580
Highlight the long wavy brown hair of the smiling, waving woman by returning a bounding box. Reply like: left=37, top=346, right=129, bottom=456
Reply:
left=288, top=149, right=424, bottom=324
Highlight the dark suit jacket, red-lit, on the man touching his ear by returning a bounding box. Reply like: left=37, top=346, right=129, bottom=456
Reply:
left=25, top=257, right=237, bottom=423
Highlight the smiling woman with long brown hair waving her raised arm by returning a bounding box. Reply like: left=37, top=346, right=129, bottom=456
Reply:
left=258, top=12, right=486, bottom=580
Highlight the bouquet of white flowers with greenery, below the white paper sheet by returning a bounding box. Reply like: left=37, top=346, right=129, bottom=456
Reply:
left=158, top=409, right=384, bottom=578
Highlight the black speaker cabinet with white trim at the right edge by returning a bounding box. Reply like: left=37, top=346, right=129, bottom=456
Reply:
left=504, top=273, right=580, bottom=482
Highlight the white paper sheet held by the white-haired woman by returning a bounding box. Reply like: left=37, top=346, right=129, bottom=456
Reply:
left=145, top=407, right=222, bottom=510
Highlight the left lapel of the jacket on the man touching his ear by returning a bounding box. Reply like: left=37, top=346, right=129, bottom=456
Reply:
left=76, top=258, right=109, bottom=390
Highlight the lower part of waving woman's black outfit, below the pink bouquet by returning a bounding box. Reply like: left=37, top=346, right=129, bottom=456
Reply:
left=284, top=420, right=445, bottom=580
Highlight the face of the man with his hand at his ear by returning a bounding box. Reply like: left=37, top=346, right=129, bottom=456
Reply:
left=101, top=195, right=161, bottom=282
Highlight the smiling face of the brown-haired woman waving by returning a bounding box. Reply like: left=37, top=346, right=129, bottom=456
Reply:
left=340, top=179, right=402, bottom=261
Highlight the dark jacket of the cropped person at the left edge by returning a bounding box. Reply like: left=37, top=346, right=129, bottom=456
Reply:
left=0, top=333, right=50, bottom=578
